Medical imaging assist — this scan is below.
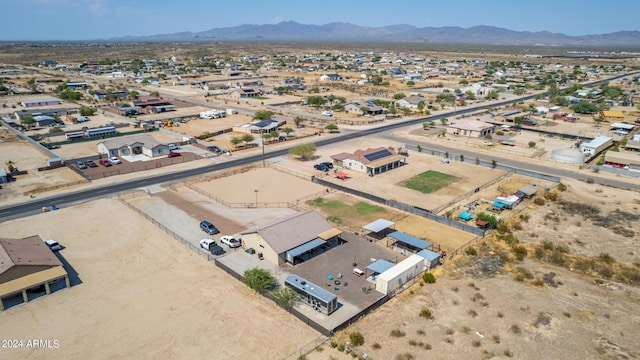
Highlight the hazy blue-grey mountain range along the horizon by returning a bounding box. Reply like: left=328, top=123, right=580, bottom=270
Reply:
left=112, top=21, right=640, bottom=47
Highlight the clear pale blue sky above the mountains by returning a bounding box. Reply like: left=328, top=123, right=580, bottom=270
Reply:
left=0, top=0, right=640, bottom=40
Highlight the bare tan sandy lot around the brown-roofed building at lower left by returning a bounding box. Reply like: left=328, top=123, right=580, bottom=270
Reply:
left=0, top=199, right=318, bottom=359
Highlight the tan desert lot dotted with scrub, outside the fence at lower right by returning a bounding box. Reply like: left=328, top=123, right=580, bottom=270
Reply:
left=308, top=176, right=640, bottom=360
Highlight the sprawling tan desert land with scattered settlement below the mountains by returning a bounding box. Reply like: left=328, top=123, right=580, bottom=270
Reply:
left=0, top=20, right=640, bottom=360
